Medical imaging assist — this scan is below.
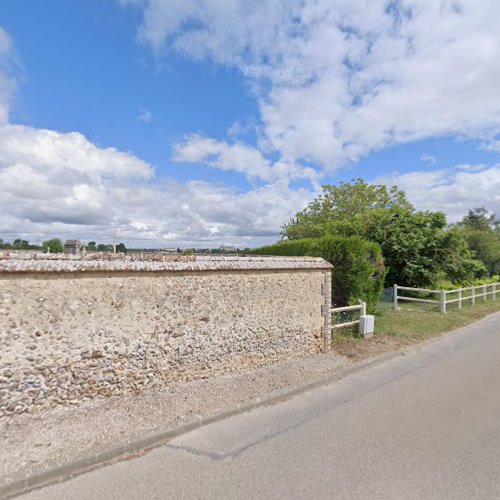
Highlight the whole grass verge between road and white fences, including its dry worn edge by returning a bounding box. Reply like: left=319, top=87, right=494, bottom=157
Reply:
left=332, top=298, right=500, bottom=361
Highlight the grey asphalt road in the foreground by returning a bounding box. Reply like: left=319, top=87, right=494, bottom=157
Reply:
left=23, top=314, right=500, bottom=500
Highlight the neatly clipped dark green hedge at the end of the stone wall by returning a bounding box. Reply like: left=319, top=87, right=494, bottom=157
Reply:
left=249, top=236, right=386, bottom=311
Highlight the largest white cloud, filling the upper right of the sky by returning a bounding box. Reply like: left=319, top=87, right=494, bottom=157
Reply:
left=125, top=0, right=500, bottom=169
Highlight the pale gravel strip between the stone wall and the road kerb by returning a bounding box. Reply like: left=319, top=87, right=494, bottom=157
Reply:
left=0, top=352, right=352, bottom=488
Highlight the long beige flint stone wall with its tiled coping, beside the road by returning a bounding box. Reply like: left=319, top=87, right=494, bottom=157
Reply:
left=0, top=256, right=330, bottom=416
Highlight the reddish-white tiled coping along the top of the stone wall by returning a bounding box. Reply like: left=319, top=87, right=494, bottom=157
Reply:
left=0, top=252, right=332, bottom=273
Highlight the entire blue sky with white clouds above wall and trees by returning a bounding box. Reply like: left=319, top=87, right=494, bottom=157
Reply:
left=0, top=0, right=500, bottom=248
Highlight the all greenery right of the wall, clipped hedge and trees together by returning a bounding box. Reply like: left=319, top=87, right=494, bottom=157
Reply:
left=252, top=178, right=500, bottom=305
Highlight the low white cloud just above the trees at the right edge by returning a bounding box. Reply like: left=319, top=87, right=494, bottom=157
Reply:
left=373, top=165, right=500, bottom=222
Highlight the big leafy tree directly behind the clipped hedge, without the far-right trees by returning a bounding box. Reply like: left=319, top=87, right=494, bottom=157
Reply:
left=282, top=179, right=480, bottom=286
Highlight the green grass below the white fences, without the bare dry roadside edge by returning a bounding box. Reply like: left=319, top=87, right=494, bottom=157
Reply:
left=332, top=297, right=500, bottom=346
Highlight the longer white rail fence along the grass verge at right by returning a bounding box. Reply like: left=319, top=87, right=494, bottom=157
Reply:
left=394, top=283, right=500, bottom=314
